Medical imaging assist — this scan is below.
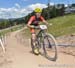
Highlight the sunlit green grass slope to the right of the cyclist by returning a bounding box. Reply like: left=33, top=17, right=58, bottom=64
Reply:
left=48, top=14, right=75, bottom=36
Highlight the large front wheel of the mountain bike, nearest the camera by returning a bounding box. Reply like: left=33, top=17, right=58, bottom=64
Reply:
left=43, top=34, right=57, bottom=60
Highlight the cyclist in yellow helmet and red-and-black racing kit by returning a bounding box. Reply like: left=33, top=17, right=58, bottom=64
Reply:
left=27, top=8, right=48, bottom=54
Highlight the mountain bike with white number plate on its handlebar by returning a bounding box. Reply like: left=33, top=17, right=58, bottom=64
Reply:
left=31, top=25, right=57, bottom=60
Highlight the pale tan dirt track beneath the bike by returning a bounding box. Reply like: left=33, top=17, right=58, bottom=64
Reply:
left=0, top=31, right=75, bottom=68
